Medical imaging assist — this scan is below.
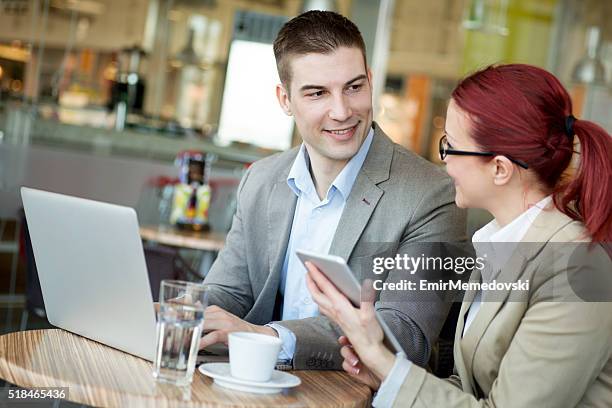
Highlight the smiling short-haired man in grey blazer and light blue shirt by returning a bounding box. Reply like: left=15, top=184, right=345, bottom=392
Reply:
left=200, top=11, right=465, bottom=369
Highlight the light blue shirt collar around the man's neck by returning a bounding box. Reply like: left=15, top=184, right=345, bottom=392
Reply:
left=287, top=127, right=374, bottom=200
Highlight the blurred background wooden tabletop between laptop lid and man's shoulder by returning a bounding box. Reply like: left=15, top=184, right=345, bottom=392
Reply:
left=140, top=225, right=225, bottom=251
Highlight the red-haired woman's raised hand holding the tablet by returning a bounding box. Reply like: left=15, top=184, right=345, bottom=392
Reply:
left=306, top=262, right=395, bottom=385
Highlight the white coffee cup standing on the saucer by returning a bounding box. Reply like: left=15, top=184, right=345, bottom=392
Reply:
left=228, top=332, right=282, bottom=382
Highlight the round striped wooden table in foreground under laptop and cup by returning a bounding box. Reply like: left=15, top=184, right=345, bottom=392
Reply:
left=0, top=329, right=371, bottom=407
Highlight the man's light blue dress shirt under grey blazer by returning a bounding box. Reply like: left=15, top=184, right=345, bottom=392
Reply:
left=269, top=129, right=374, bottom=359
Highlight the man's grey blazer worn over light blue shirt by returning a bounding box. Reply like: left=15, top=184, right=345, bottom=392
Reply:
left=204, top=123, right=465, bottom=369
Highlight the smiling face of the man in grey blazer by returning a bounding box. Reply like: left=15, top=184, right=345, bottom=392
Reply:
left=277, top=47, right=372, bottom=164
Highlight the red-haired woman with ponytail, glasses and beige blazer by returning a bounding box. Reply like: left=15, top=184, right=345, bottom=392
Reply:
left=307, top=64, right=612, bottom=407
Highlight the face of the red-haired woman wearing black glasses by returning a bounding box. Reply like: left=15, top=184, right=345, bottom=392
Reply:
left=444, top=99, right=495, bottom=208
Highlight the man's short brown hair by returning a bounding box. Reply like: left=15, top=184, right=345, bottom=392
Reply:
left=274, top=10, right=367, bottom=91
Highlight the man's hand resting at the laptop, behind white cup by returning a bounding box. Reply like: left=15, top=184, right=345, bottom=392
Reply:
left=200, top=306, right=278, bottom=349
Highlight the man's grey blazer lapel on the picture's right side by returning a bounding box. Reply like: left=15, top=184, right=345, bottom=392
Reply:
left=329, top=123, right=393, bottom=260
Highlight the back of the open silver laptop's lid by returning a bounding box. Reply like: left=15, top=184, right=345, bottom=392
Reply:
left=21, top=187, right=156, bottom=361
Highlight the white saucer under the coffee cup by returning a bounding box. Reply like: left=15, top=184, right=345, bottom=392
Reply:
left=198, top=363, right=302, bottom=394
